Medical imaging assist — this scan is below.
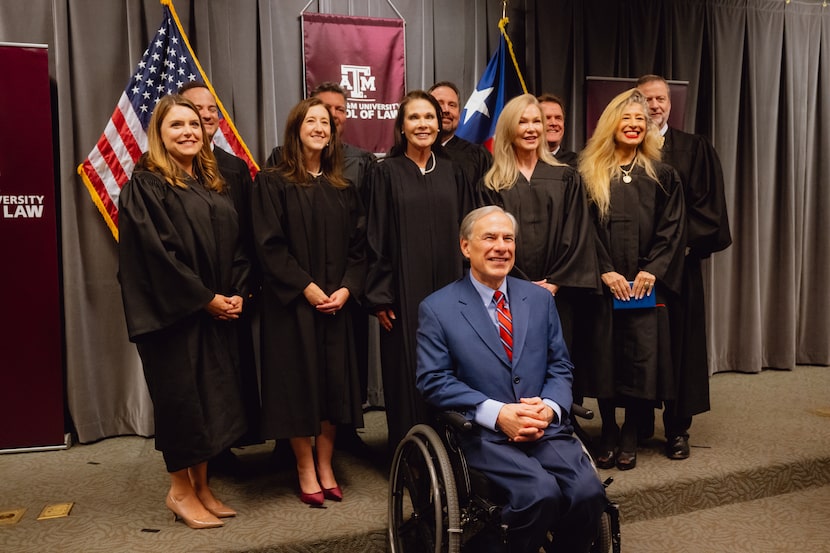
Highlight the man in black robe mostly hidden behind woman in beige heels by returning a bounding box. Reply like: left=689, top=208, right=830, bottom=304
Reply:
left=179, top=81, right=262, bottom=472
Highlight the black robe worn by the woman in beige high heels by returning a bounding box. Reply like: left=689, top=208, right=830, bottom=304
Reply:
left=118, top=171, right=249, bottom=472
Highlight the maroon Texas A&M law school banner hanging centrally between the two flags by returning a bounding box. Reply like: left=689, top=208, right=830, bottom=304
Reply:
left=302, top=13, right=406, bottom=153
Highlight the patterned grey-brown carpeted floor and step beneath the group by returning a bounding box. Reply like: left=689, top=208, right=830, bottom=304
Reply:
left=0, top=367, right=830, bottom=553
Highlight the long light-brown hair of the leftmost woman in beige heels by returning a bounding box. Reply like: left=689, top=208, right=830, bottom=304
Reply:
left=142, top=94, right=225, bottom=192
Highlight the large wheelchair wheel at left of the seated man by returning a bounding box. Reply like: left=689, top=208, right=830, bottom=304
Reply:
left=388, top=424, right=461, bottom=553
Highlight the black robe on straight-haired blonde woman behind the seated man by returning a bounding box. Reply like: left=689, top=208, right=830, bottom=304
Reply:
left=481, top=161, right=601, bottom=352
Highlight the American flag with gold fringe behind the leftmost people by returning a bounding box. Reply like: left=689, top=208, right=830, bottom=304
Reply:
left=78, top=0, right=259, bottom=240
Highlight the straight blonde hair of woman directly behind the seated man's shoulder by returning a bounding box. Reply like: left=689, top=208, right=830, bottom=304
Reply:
left=484, top=94, right=563, bottom=192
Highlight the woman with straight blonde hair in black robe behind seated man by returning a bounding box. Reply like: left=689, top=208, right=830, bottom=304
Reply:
left=481, top=94, right=600, bottom=356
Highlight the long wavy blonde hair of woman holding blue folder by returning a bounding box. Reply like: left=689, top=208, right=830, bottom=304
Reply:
left=578, top=88, right=662, bottom=220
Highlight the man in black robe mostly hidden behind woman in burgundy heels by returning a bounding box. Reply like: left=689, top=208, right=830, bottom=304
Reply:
left=265, top=81, right=380, bottom=457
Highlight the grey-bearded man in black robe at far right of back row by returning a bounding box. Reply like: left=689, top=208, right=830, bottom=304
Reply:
left=637, top=75, right=732, bottom=459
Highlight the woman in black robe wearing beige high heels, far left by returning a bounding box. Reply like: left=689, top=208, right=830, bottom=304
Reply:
left=118, top=95, right=249, bottom=528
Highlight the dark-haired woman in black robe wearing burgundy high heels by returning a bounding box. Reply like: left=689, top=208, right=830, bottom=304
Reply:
left=251, top=98, right=366, bottom=505
